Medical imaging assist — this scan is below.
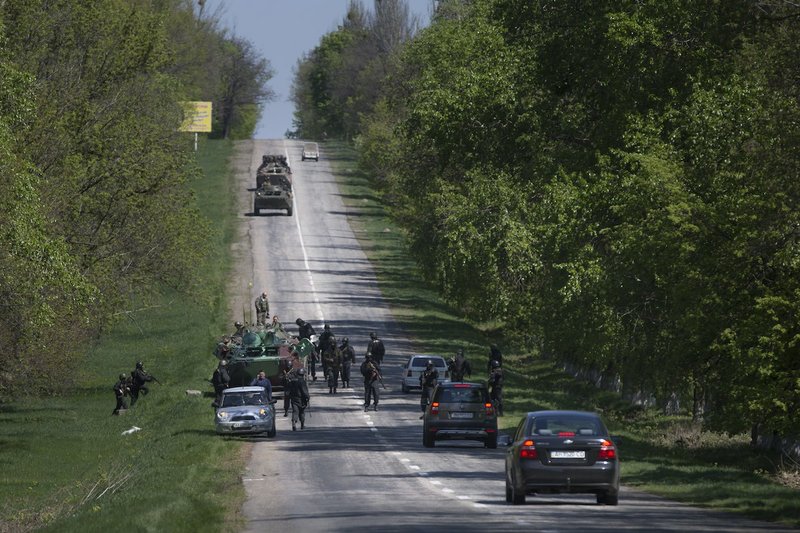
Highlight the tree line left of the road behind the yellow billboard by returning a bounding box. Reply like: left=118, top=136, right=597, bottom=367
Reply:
left=0, top=0, right=272, bottom=398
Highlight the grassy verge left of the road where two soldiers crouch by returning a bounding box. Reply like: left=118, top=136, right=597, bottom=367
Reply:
left=0, top=141, right=244, bottom=532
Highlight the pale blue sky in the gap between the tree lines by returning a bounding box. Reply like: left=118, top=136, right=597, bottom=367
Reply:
left=205, top=0, right=431, bottom=139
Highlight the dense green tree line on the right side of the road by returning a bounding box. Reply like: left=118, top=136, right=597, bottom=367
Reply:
left=294, top=0, right=800, bottom=434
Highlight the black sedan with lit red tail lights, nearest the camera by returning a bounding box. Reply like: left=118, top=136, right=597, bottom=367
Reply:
left=506, top=411, right=619, bottom=505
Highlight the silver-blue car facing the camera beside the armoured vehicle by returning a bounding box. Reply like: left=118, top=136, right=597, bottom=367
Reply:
left=215, top=387, right=276, bottom=438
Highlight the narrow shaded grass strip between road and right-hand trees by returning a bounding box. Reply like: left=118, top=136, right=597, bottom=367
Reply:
left=323, top=142, right=800, bottom=527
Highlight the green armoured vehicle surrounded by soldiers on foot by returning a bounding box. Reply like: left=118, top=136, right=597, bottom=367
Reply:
left=214, top=323, right=315, bottom=398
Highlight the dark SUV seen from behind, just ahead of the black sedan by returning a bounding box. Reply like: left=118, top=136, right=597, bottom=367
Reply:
left=422, top=382, right=497, bottom=448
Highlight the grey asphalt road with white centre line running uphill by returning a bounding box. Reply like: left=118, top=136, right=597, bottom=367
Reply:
left=225, top=140, right=789, bottom=532
